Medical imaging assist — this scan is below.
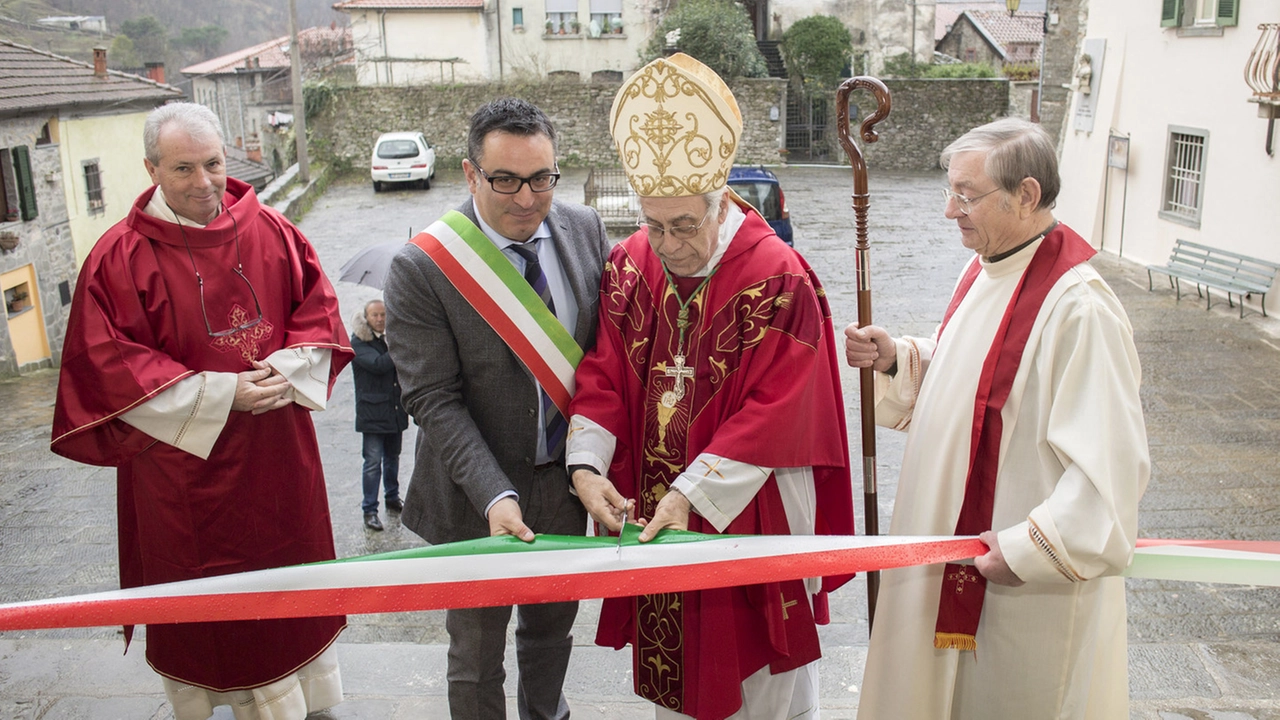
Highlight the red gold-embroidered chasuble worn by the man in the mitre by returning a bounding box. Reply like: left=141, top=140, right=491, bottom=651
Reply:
left=571, top=210, right=854, bottom=719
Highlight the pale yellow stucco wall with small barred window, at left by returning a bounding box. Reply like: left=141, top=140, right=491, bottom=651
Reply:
left=59, top=110, right=151, bottom=260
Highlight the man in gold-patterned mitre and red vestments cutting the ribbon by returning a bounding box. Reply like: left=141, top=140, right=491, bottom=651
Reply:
left=566, top=54, right=854, bottom=720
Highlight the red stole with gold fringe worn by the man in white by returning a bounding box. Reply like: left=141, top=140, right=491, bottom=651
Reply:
left=933, top=223, right=1096, bottom=650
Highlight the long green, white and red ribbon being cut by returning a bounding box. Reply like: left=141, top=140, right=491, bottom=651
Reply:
left=0, top=525, right=1280, bottom=630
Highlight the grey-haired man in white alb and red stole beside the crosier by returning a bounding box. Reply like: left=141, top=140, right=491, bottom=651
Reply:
left=845, top=118, right=1149, bottom=720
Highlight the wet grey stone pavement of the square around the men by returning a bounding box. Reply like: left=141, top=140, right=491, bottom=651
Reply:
left=0, top=168, right=1280, bottom=720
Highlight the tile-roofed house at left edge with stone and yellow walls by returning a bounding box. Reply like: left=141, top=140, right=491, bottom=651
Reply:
left=0, top=40, right=182, bottom=375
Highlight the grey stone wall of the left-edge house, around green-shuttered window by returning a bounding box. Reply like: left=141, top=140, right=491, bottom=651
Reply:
left=0, top=115, right=76, bottom=377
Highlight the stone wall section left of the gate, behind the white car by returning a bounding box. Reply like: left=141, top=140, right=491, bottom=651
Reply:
left=308, top=78, right=786, bottom=169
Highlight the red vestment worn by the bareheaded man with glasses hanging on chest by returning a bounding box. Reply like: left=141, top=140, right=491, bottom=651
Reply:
left=52, top=178, right=352, bottom=691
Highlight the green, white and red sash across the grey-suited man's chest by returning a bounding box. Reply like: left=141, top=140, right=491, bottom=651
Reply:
left=410, top=210, right=582, bottom=418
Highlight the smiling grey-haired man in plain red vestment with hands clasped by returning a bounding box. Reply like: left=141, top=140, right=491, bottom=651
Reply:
left=52, top=104, right=352, bottom=720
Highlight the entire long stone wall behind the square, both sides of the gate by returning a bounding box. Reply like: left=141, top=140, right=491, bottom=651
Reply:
left=310, top=78, right=1009, bottom=172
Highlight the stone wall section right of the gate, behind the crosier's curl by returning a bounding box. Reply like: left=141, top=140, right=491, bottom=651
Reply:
left=828, top=78, right=1009, bottom=172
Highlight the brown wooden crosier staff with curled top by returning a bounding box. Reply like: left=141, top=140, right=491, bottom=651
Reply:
left=836, top=76, right=891, bottom=632
